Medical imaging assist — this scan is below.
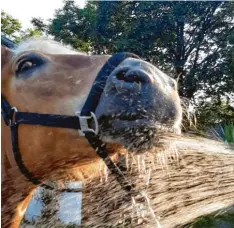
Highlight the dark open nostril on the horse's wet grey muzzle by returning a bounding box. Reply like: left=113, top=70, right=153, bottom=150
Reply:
left=116, top=70, right=144, bottom=83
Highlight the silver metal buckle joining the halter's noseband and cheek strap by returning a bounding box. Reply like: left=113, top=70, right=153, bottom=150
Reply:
left=75, top=112, right=99, bottom=136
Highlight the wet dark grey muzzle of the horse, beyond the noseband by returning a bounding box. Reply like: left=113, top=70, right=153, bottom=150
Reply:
left=96, top=58, right=181, bottom=152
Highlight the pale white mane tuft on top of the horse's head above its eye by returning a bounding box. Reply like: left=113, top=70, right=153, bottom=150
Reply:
left=13, top=37, right=87, bottom=57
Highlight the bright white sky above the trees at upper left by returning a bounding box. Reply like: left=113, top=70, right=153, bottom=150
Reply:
left=1, top=0, right=86, bottom=29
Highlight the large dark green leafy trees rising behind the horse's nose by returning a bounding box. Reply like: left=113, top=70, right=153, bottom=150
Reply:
left=50, top=1, right=234, bottom=104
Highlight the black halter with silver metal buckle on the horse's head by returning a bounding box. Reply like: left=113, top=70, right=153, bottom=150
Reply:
left=1, top=37, right=139, bottom=191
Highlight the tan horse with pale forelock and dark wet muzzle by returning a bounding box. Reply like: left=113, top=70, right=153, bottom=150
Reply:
left=1, top=39, right=182, bottom=228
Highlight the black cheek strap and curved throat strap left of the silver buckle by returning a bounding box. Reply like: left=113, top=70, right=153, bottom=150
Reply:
left=1, top=96, right=82, bottom=193
